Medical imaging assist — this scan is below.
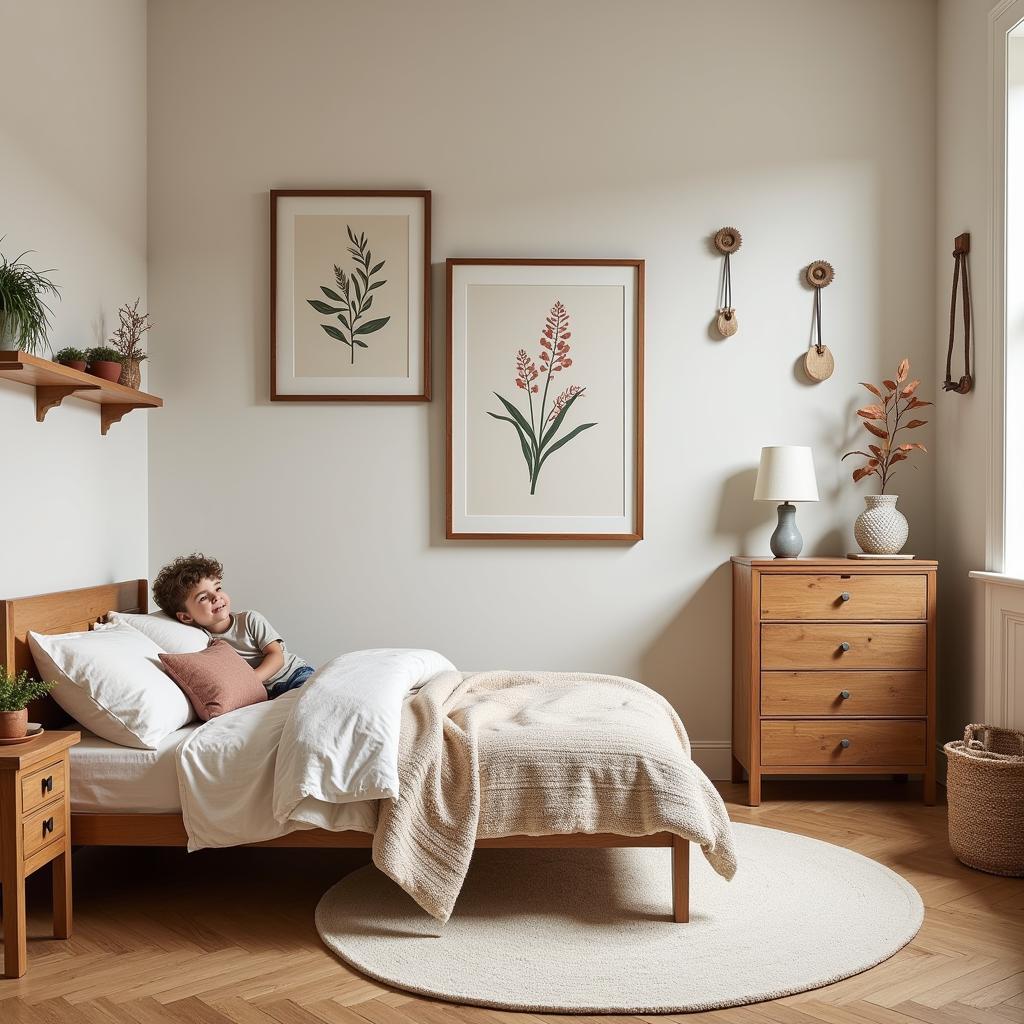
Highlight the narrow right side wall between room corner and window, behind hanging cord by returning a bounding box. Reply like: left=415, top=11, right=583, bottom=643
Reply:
left=935, top=0, right=1002, bottom=740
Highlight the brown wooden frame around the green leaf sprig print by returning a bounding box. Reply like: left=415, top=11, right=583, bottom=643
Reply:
left=270, top=188, right=430, bottom=401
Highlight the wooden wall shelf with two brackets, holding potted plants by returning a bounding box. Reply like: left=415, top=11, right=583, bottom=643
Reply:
left=0, top=351, right=164, bottom=435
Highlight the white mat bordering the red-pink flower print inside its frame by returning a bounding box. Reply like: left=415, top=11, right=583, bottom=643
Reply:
left=450, top=263, right=638, bottom=536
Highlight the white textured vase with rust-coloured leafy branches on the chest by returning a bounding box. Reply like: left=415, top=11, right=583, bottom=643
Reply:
left=843, top=359, right=932, bottom=555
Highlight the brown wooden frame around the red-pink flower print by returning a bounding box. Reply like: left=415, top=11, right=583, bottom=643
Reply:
left=444, top=258, right=645, bottom=543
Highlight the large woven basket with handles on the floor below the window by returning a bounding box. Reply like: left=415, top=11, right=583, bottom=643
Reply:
left=943, top=725, right=1024, bottom=877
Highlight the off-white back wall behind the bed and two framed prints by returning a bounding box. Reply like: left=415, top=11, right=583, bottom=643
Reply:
left=150, top=0, right=938, bottom=765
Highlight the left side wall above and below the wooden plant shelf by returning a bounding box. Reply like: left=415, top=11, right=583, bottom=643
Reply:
left=0, top=0, right=153, bottom=597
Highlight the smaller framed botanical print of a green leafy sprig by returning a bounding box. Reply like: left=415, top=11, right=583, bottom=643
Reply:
left=270, top=188, right=430, bottom=401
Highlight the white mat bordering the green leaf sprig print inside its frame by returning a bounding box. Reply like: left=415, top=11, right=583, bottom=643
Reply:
left=274, top=196, right=425, bottom=395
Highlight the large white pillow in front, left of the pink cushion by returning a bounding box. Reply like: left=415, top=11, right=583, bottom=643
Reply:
left=29, top=623, right=195, bottom=750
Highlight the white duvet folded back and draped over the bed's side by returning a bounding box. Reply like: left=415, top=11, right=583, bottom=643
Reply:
left=177, top=649, right=455, bottom=851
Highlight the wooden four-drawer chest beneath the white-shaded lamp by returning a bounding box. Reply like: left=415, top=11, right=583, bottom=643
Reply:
left=732, top=558, right=938, bottom=806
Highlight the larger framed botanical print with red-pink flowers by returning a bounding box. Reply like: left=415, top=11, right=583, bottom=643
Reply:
left=446, top=259, right=644, bottom=541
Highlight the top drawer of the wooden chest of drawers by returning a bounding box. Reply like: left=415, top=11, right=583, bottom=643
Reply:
left=761, top=573, right=928, bottom=620
